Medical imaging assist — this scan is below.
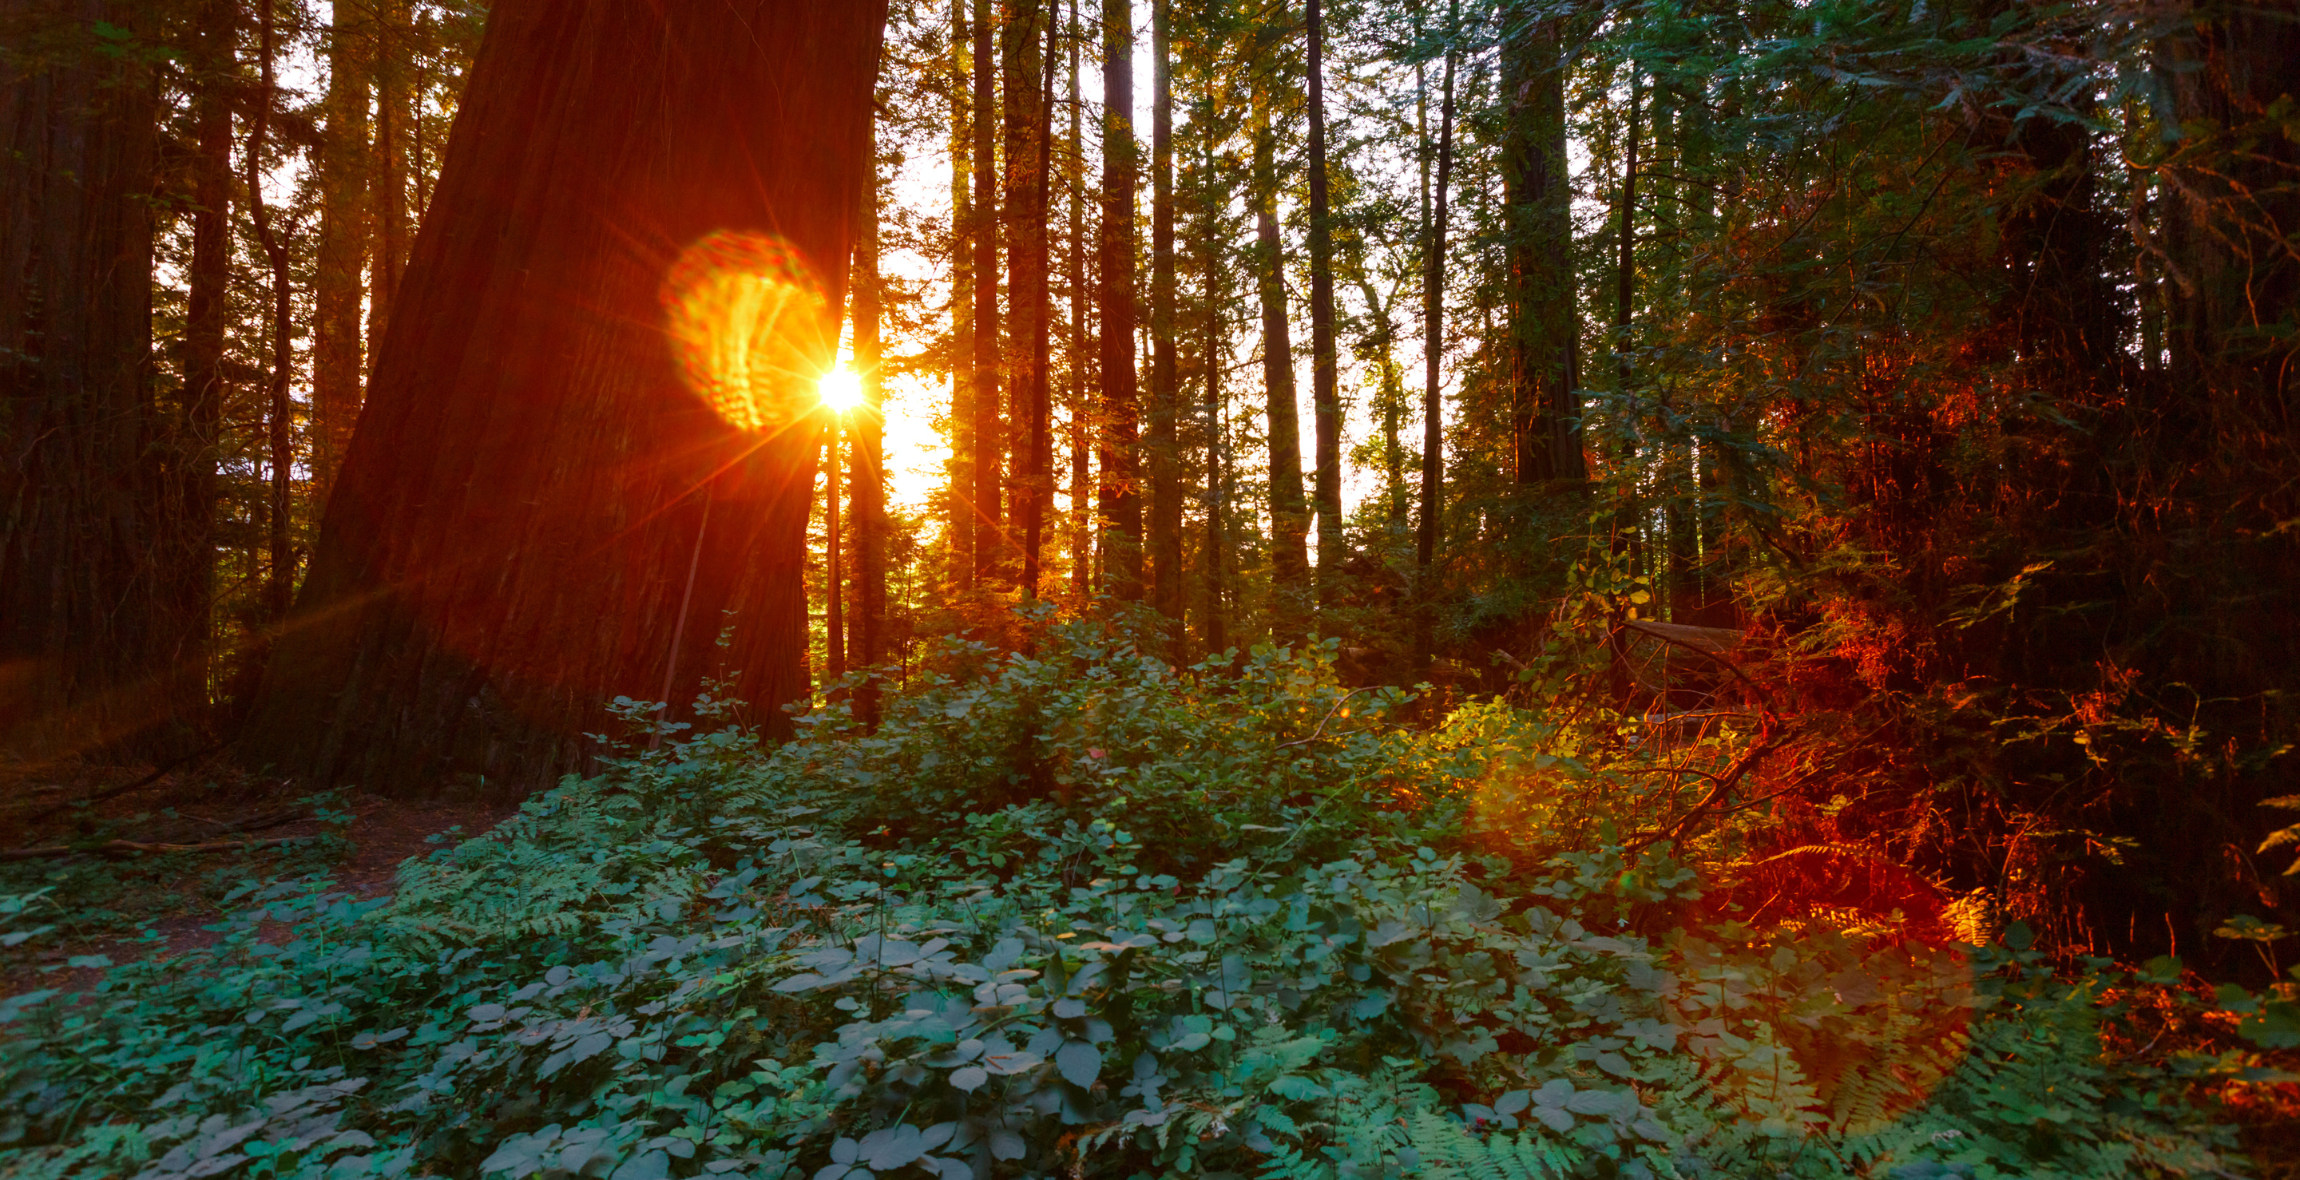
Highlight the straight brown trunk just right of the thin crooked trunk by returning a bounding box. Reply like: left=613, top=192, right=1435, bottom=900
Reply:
left=311, top=2, right=375, bottom=506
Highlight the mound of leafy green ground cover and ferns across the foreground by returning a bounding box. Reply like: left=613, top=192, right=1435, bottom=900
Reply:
left=0, top=626, right=2272, bottom=1180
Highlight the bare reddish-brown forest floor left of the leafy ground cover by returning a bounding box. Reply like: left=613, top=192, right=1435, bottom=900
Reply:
left=0, top=764, right=518, bottom=996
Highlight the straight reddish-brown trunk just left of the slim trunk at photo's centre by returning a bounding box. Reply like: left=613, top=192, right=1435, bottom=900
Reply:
left=1097, top=0, right=1143, bottom=600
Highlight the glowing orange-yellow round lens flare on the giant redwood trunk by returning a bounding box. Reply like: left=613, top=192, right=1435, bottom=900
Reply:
left=660, top=230, right=837, bottom=430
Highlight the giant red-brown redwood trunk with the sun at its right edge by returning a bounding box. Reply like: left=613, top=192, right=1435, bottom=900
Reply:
left=244, top=0, right=886, bottom=794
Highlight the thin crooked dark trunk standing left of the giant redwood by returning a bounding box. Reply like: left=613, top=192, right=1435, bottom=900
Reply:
left=242, top=0, right=297, bottom=621
